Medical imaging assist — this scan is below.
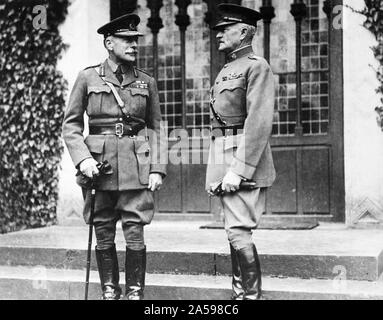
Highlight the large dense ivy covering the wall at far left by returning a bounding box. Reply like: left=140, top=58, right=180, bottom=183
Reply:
left=0, top=0, right=68, bottom=233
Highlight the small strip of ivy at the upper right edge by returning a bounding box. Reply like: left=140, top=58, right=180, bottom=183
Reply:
left=359, top=0, right=383, bottom=131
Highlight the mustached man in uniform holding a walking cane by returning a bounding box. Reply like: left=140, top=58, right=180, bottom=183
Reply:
left=63, top=14, right=166, bottom=300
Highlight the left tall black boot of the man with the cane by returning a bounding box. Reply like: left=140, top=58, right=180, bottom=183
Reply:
left=96, top=245, right=121, bottom=300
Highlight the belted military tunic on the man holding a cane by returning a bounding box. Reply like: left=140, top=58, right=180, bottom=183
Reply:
left=63, top=59, right=166, bottom=191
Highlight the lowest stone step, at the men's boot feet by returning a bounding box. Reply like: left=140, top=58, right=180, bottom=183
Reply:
left=0, top=266, right=383, bottom=300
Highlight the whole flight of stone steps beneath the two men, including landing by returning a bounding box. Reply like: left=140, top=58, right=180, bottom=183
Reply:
left=0, top=222, right=383, bottom=300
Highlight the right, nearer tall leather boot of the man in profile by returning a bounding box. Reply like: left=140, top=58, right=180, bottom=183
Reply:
left=236, top=244, right=262, bottom=300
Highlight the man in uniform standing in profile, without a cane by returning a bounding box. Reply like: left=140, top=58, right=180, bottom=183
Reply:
left=206, top=4, right=275, bottom=300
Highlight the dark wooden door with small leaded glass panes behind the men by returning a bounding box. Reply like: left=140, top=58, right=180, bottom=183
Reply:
left=139, top=0, right=344, bottom=221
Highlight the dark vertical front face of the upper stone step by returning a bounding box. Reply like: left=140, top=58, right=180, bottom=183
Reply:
left=0, top=247, right=382, bottom=281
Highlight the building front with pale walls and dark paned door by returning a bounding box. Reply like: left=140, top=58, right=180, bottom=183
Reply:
left=58, top=0, right=383, bottom=225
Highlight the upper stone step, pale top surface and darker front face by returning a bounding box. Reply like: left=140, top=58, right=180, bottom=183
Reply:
left=0, top=221, right=383, bottom=281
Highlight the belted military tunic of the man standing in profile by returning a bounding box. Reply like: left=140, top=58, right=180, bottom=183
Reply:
left=206, top=46, right=275, bottom=189
